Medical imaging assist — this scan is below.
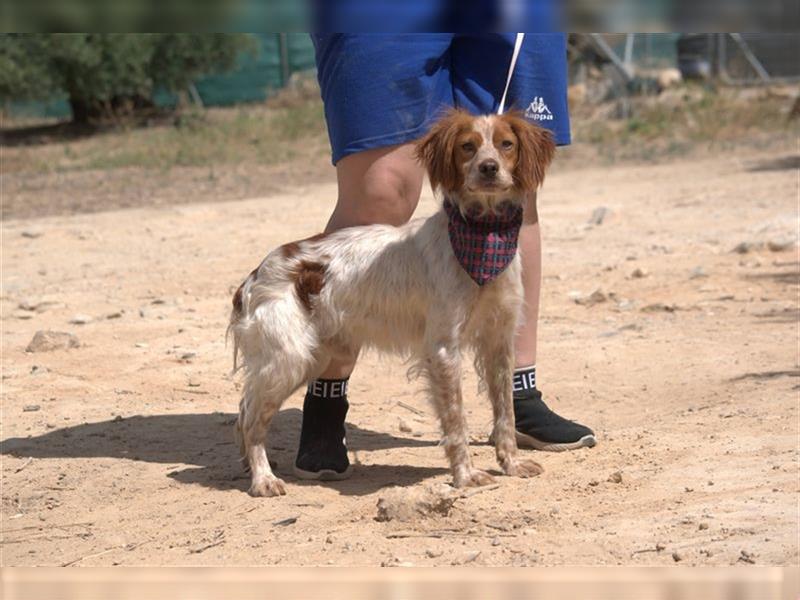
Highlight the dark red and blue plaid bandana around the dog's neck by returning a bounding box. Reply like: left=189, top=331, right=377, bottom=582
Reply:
left=444, top=200, right=522, bottom=285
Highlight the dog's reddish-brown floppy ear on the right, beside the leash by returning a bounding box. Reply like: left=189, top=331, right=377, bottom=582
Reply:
left=500, top=112, right=556, bottom=192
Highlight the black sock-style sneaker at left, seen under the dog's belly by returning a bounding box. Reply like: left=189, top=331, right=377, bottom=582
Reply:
left=294, top=394, right=352, bottom=481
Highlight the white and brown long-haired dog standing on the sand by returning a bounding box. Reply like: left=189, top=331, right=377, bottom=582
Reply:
left=229, top=111, right=555, bottom=496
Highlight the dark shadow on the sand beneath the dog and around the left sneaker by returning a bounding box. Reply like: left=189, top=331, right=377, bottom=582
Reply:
left=0, top=408, right=446, bottom=495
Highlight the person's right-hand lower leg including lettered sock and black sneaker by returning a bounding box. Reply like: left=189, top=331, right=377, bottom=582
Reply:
left=514, top=194, right=596, bottom=451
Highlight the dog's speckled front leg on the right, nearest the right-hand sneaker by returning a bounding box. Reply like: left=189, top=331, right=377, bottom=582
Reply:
left=476, top=327, right=544, bottom=477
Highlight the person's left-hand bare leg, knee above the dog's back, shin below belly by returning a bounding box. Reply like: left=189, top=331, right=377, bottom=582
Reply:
left=320, top=144, right=424, bottom=379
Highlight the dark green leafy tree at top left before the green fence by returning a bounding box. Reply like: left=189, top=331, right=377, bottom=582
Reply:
left=0, top=33, right=255, bottom=123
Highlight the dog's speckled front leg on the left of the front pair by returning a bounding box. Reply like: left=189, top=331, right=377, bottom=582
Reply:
left=425, top=343, right=494, bottom=487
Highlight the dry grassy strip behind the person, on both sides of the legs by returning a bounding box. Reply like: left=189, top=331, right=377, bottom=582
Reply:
left=0, top=86, right=799, bottom=218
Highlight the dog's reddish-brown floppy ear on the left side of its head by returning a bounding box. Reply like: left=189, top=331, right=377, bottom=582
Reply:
left=415, top=110, right=473, bottom=192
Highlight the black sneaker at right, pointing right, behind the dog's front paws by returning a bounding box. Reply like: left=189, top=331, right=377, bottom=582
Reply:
left=514, top=389, right=597, bottom=452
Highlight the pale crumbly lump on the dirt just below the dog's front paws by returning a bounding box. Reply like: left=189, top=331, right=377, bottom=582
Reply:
left=375, top=483, right=459, bottom=522
